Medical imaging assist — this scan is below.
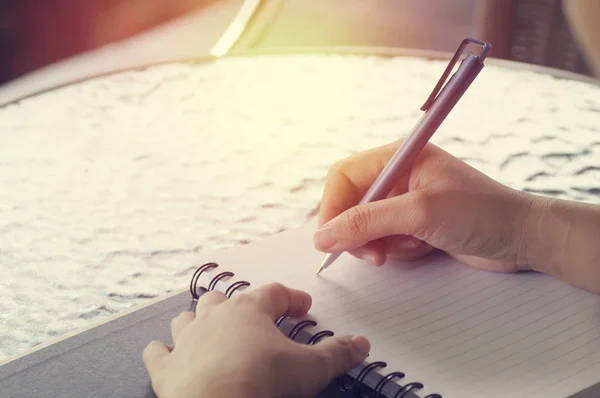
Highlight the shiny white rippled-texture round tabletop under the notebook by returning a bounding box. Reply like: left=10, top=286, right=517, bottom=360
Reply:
left=0, top=55, right=600, bottom=359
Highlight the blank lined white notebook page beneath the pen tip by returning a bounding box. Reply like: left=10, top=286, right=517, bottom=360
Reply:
left=201, top=224, right=600, bottom=398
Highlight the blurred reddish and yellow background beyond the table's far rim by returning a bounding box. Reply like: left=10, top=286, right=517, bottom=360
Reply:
left=0, top=0, right=600, bottom=87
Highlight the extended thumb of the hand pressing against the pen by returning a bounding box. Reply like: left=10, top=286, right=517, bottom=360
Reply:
left=314, top=191, right=426, bottom=253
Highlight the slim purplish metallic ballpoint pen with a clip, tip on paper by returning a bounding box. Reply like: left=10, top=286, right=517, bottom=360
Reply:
left=317, top=38, right=492, bottom=275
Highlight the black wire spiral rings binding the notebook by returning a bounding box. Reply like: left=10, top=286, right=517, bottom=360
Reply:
left=190, top=263, right=443, bottom=398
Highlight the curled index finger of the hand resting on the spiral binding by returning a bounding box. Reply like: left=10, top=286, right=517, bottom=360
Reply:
left=247, top=283, right=312, bottom=321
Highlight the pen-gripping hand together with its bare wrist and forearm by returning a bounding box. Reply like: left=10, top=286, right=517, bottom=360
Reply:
left=314, top=141, right=600, bottom=294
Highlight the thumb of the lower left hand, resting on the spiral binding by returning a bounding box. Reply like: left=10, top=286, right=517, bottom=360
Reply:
left=306, top=336, right=371, bottom=388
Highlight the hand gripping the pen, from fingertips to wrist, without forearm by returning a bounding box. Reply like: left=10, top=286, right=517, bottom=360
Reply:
left=314, top=141, right=533, bottom=272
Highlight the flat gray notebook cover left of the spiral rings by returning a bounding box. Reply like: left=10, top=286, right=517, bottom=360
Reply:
left=0, top=286, right=600, bottom=398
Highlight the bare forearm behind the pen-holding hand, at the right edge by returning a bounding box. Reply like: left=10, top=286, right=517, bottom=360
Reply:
left=520, top=197, right=600, bottom=293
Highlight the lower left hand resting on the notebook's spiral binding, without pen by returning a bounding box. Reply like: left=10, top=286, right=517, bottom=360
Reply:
left=143, top=284, right=369, bottom=398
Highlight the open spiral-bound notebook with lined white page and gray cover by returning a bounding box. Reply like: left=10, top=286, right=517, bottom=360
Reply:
left=0, top=219, right=600, bottom=398
